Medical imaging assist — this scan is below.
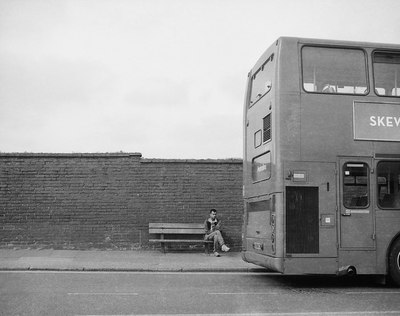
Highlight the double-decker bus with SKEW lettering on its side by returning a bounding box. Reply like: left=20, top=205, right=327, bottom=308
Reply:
left=242, top=37, right=400, bottom=284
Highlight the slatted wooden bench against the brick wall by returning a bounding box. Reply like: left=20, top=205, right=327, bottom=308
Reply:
left=149, top=223, right=213, bottom=253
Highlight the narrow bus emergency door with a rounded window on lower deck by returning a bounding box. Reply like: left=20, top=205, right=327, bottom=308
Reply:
left=339, top=157, right=375, bottom=249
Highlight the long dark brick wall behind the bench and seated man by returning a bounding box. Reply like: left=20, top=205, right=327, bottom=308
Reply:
left=0, top=153, right=243, bottom=250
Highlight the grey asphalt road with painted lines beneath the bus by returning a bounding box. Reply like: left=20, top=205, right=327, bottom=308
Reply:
left=0, top=271, right=400, bottom=315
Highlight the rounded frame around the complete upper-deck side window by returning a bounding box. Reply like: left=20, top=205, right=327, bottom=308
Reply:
left=299, top=44, right=371, bottom=96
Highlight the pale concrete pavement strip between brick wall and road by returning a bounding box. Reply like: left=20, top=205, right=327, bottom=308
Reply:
left=0, top=249, right=266, bottom=272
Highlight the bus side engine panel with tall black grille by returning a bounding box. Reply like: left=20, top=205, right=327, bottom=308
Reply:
left=285, top=162, right=338, bottom=258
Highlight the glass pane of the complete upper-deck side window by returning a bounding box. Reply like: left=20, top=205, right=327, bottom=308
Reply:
left=302, top=46, right=368, bottom=95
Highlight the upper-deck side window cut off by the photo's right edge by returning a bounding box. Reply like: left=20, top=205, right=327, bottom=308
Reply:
left=372, top=52, right=400, bottom=97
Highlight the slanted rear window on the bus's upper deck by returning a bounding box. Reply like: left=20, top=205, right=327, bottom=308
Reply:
left=250, top=54, right=274, bottom=107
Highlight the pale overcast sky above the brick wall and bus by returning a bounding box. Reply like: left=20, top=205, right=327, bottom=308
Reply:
left=0, top=0, right=400, bottom=158
